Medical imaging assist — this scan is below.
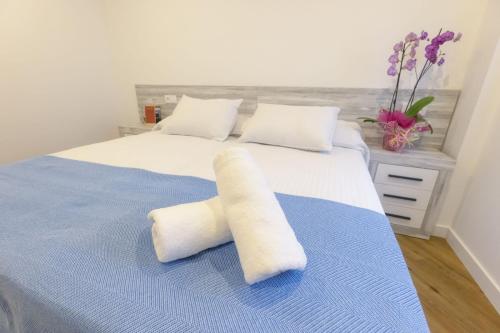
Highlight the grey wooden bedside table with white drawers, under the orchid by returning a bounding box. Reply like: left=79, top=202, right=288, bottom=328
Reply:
left=369, top=146, right=455, bottom=239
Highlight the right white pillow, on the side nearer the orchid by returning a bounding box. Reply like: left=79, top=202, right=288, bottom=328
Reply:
left=240, top=103, right=340, bottom=151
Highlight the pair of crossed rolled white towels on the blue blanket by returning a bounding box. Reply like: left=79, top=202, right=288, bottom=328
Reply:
left=148, top=148, right=307, bottom=284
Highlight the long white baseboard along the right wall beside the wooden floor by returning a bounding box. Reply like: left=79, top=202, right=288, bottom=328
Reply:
left=447, top=228, right=500, bottom=313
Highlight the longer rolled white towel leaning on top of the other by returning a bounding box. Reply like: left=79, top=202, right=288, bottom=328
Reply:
left=214, top=148, right=307, bottom=284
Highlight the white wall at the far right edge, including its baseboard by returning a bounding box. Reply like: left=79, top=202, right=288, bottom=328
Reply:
left=449, top=38, right=500, bottom=312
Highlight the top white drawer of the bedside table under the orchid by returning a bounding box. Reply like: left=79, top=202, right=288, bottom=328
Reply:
left=375, top=163, right=439, bottom=191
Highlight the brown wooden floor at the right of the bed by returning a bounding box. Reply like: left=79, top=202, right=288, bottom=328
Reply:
left=397, top=235, right=500, bottom=333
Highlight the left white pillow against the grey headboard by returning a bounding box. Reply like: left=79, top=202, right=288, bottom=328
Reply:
left=162, top=95, right=242, bottom=141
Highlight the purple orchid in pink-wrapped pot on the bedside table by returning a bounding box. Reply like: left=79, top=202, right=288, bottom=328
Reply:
left=361, top=29, right=462, bottom=151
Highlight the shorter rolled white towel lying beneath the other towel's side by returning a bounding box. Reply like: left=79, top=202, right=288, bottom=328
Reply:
left=148, top=197, right=233, bottom=262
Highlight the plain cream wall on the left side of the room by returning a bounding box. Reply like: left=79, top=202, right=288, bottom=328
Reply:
left=0, top=0, right=117, bottom=163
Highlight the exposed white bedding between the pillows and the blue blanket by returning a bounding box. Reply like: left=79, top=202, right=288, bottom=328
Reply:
left=53, top=132, right=383, bottom=213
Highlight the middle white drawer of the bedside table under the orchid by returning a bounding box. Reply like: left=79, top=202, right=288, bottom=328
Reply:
left=375, top=183, right=432, bottom=210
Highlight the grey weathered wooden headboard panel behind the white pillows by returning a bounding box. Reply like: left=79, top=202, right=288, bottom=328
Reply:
left=135, top=85, right=460, bottom=150
